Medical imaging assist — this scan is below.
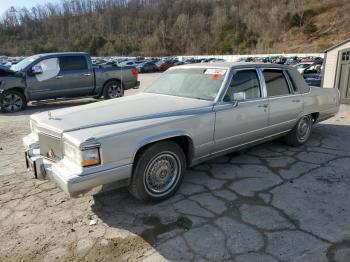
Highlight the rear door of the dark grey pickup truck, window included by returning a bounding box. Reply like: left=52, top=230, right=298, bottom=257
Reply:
left=56, top=55, right=94, bottom=97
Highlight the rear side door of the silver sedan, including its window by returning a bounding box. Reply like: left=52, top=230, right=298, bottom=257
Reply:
left=262, top=69, right=303, bottom=134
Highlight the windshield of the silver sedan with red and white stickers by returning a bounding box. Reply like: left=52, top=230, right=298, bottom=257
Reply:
left=144, top=68, right=227, bottom=101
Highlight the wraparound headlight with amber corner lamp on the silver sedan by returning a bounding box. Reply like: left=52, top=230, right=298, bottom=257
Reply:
left=64, top=142, right=101, bottom=167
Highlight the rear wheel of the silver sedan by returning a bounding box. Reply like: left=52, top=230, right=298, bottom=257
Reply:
left=285, top=115, right=313, bottom=146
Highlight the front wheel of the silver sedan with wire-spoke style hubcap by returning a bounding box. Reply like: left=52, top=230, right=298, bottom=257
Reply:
left=128, top=141, right=186, bottom=202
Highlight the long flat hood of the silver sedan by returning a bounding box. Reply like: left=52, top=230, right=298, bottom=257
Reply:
left=31, top=93, right=213, bottom=136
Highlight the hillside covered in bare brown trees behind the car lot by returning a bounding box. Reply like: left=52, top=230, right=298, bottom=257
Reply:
left=0, top=0, right=350, bottom=56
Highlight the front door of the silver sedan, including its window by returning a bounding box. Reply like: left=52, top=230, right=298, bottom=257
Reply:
left=214, top=69, right=268, bottom=152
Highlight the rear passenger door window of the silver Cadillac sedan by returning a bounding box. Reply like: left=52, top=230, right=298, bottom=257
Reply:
left=263, top=69, right=290, bottom=96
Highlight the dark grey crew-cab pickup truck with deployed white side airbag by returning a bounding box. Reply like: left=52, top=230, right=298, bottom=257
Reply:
left=0, top=53, right=139, bottom=112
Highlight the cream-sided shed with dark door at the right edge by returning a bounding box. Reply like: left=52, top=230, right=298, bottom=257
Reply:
left=321, top=38, right=350, bottom=104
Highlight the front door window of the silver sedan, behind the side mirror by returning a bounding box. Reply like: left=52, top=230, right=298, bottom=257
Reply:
left=224, top=70, right=261, bottom=102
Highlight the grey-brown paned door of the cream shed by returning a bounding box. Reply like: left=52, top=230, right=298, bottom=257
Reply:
left=338, top=49, right=350, bottom=104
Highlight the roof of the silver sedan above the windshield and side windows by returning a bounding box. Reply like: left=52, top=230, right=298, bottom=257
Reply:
left=172, top=62, right=289, bottom=68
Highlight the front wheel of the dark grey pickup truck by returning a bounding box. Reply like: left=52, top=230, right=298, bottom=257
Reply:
left=0, top=90, right=27, bottom=113
